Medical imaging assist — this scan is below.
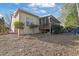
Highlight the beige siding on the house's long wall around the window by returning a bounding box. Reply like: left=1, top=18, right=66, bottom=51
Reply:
left=19, top=12, right=39, bottom=34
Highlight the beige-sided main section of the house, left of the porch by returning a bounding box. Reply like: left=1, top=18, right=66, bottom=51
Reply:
left=11, top=9, right=39, bottom=34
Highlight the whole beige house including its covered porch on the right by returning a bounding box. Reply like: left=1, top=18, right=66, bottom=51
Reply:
left=11, top=9, right=60, bottom=34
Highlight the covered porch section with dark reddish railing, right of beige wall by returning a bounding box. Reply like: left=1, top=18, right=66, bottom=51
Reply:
left=39, top=15, right=60, bottom=32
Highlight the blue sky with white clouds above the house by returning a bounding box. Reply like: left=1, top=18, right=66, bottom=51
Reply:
left=0, top=3, right=63, bottom=23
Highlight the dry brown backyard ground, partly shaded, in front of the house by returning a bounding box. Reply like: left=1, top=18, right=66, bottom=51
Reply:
left=0, top=33, right=79, bottom=56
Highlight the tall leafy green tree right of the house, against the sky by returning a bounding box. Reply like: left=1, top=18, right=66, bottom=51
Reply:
left=61, top=3, right=78, bottom=27
